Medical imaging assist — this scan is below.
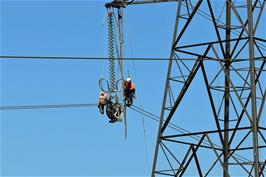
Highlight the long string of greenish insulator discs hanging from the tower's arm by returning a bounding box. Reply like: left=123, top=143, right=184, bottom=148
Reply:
left=108, top=9, right=116, bottom=92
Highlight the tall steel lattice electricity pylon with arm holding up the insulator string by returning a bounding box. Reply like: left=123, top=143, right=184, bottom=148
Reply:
left=105, top=0, right=266, bottom=177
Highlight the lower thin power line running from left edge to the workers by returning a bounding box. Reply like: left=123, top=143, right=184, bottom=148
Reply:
left=0, top=103, right=97, bottom=110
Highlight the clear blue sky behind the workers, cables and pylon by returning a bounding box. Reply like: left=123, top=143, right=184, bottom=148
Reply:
left=0, top=0, right=265, bottom=176
